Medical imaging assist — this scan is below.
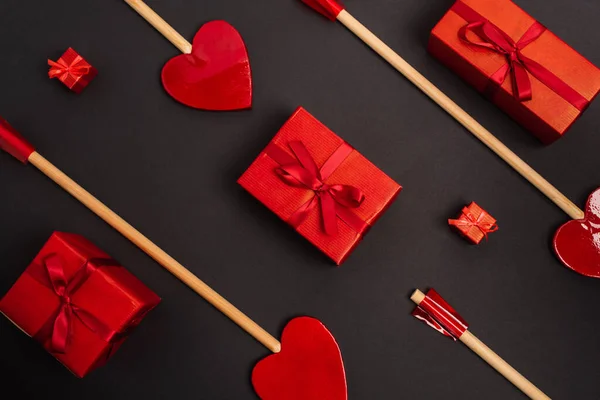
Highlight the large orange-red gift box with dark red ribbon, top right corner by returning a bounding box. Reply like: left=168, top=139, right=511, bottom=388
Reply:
left=429, top=0, right=600, bottom=143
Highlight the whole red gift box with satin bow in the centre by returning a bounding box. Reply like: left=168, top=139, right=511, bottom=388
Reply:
left=238, top=107, right=402, bottom=265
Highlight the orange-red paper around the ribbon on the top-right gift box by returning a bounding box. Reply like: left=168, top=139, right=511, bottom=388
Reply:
left=429, top=0, right=600, bottom=143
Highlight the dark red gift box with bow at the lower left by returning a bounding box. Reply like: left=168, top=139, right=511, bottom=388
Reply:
left=0, top=232, right=160, bottom=378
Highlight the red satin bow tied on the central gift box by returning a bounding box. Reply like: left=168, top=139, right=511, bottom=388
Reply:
left=275, top=141, right=365, bottom=235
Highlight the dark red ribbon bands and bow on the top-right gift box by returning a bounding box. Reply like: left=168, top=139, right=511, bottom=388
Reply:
left=452, top=2, right=589, bottom=111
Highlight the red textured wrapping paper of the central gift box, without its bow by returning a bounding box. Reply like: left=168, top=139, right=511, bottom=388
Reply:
left=238, top=107, right=402, bottom=265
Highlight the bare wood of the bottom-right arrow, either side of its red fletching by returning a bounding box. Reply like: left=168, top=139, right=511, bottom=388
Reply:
left=411, top=290, right=550, bottom=400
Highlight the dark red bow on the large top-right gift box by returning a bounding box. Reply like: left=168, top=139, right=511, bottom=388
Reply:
left=459, top=20, right=547, bottom=102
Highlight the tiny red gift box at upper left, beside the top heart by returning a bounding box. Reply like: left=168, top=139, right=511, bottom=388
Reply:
left=48, top=47, right=98, bottom=93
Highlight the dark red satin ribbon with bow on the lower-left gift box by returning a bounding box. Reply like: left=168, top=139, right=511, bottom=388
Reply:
left=28, top=254, right=126, bottom=354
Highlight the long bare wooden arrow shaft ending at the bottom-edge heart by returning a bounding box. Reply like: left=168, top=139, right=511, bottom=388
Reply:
left=29, top=152, right=281, bottom=353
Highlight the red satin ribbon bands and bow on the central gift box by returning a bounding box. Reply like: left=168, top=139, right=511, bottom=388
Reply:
left=265, top=141, right=368, bottom=236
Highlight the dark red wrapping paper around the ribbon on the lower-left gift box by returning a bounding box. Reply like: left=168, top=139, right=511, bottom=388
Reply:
left=0, top=232, right=160, bottom=377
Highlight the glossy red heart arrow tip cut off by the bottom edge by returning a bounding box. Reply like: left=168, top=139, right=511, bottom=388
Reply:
left=252, top=317, right=348, bottom=400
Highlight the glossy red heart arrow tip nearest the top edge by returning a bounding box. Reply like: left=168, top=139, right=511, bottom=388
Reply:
left=162, top=21, right=252, bottom=111
